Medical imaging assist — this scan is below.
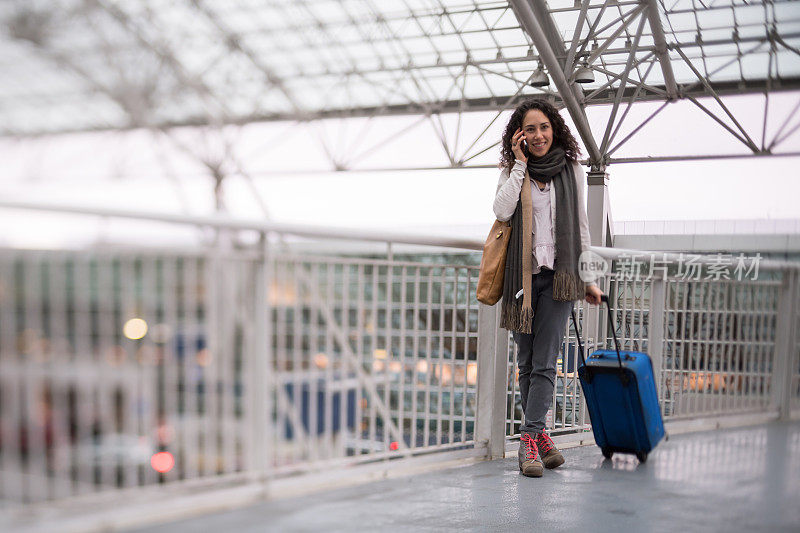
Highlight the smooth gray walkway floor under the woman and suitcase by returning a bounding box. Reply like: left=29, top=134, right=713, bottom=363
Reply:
left=130, top=422, right=800, bottom=533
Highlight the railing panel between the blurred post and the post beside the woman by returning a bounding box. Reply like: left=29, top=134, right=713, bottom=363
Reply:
left=269, top=256, right=478, bottom=465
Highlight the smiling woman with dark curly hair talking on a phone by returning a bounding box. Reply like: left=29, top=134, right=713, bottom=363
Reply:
left=494, top=100, right=603, bottom=477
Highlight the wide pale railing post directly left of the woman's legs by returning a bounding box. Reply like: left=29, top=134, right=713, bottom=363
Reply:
left=475, top=303, right=508, bottom=459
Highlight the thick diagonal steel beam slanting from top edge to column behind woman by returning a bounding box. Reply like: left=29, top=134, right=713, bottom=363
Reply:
left=509, top=0, right=602, bottom=168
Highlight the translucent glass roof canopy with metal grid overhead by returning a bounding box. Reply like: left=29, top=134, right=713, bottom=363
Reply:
left=0, top=0, right=800, bottom=135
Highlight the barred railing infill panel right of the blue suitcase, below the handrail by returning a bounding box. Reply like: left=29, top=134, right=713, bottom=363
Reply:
left=607, top=278, right=781, bottom=420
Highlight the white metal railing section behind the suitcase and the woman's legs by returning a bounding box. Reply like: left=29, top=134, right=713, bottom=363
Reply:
left=496, top=248, right=800, bottom=442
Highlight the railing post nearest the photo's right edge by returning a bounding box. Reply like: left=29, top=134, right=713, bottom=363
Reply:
left=772, top=269, right=800, bottom=420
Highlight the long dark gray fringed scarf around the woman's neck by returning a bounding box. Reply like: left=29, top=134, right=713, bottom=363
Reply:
left=500, top=147, right=585, bottom=333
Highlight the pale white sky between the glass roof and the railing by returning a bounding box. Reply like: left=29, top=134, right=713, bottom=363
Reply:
left=0, top=92, right=800, bottom=247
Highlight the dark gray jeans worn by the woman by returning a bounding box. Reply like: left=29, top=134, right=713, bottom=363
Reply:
left=513, top=269, right=572, bottom=433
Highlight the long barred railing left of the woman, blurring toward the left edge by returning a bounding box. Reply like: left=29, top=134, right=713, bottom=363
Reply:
left=0, top=245, right=478, bottom=501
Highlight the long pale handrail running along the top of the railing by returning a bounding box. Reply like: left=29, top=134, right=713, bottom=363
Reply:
left=0, top=200, right=800, bottom=270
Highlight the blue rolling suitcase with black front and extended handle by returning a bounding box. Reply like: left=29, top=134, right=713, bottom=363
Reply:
left=572, top=295, right=664, bottom=462
